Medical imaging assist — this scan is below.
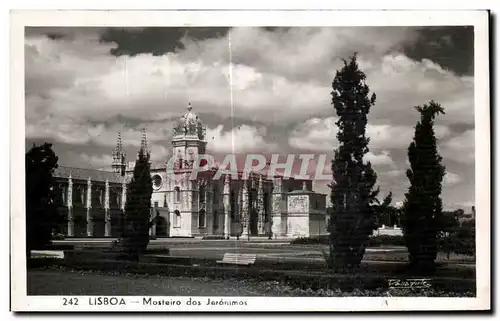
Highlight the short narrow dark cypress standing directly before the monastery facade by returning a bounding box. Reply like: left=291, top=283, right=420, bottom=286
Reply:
left=124, top=148, right=153, bottom=259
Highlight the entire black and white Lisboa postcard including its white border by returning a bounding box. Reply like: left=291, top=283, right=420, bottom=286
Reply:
left=10, top=10, right=491, bottom=312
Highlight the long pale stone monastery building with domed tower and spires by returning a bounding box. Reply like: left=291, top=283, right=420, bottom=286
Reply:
left=55, top=106, right=326, bottom=238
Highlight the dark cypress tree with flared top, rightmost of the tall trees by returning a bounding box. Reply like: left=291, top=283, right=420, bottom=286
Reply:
left=402, top=101, right=445, bottom=272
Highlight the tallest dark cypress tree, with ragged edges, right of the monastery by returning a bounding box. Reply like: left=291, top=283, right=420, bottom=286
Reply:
left=329, top=55, right=379, bottom=272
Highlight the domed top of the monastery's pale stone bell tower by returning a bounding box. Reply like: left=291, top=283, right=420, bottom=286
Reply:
left=172, top=103, right=207, bottom=169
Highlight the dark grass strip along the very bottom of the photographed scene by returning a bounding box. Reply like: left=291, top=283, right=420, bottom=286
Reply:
left=27, top=268, right=473, bottom=297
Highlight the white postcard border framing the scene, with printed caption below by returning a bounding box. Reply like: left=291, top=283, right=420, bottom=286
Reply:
left=10, top=10, right=491, bottom=311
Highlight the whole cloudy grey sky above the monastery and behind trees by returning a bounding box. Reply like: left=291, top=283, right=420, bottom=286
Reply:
left=25, top=27, right=474, bottom=209
